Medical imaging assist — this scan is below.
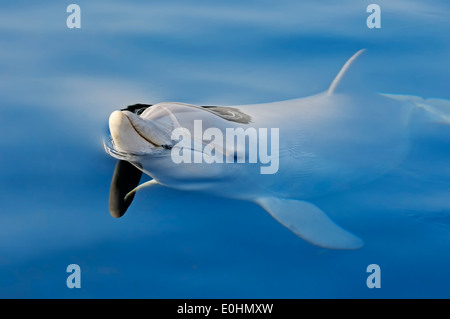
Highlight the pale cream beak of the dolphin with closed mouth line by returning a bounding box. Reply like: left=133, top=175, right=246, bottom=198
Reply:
left=109, top=111, right=171, bottom=153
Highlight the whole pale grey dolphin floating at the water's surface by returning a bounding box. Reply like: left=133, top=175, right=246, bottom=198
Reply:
left=105, top=50, right=450, bottom=249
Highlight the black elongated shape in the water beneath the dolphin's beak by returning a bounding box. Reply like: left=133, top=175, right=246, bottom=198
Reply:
left=109, top=160, right=142, bottom=218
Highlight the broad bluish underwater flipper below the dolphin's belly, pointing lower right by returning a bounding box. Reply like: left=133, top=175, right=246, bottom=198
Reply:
left=256, top=197, right=363, bottom=249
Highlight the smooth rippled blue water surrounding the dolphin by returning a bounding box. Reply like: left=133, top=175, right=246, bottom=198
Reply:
left=0, top=0, right=450, bottom=298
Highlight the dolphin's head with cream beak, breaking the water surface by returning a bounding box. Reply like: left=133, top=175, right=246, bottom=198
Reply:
left=105, top=103, right=250, bottom=189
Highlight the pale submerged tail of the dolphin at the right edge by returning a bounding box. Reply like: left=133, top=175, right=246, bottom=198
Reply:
left=379, top=93, right=450, bottom=125
